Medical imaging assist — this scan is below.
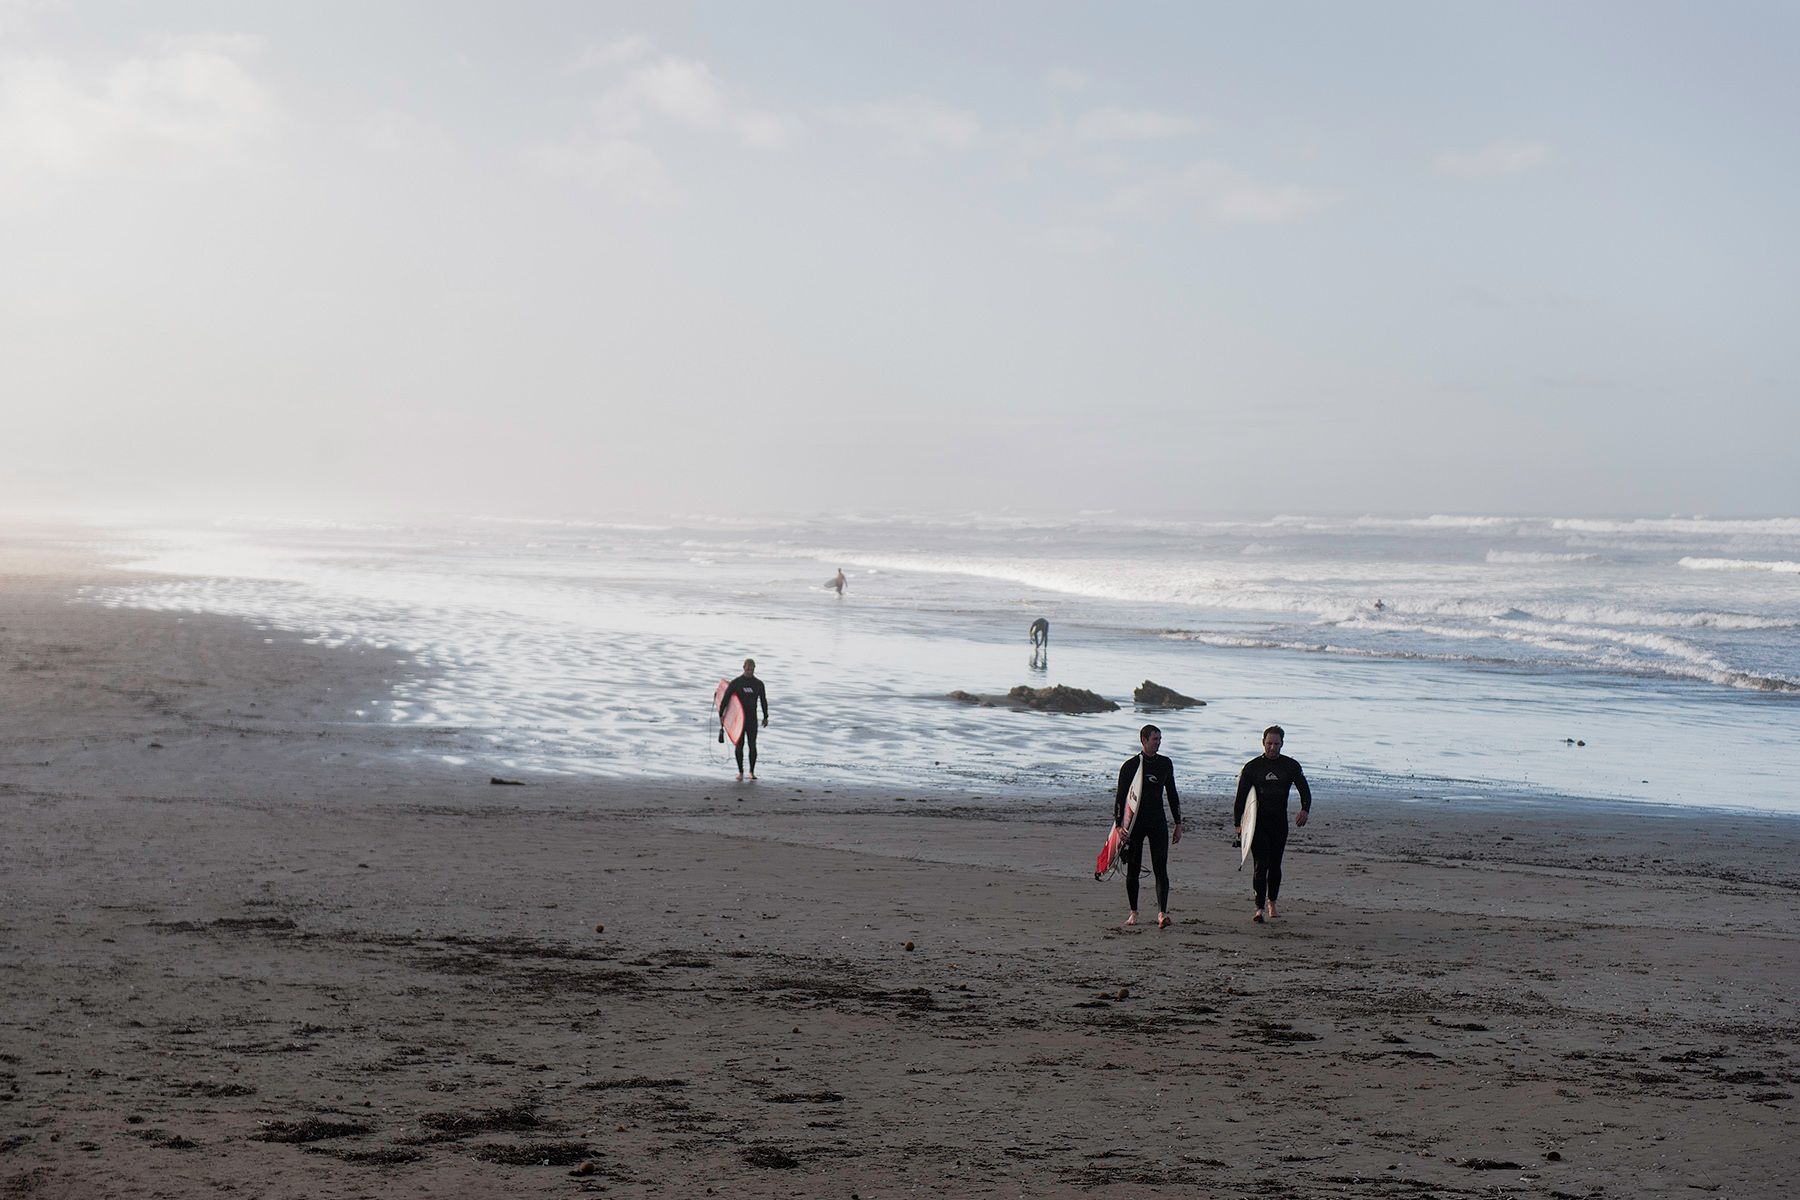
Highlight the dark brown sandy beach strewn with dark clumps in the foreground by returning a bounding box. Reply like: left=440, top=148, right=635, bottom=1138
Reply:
left=0, top=531, right=1800, bottom=1200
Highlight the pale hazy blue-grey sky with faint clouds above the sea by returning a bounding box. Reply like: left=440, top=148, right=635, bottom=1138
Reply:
left=0, top=0, right=1800, bottom=515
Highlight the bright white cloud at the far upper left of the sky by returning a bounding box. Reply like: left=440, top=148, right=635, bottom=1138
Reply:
left=0, top=36, right=274, bottom=173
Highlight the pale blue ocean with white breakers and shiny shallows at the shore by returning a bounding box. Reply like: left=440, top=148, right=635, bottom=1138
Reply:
left=83, top=513, right=1800, bottom=811
